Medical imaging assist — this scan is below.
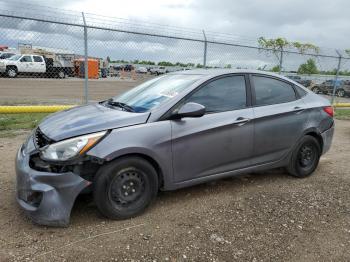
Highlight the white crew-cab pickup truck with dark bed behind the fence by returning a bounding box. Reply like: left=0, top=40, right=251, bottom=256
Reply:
left=0, top=54, right=71, bottom=78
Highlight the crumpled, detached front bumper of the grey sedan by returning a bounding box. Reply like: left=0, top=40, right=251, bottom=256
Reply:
left=16, top=136, right=91, bottom=226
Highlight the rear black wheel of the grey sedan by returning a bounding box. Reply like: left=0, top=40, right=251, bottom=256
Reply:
left=287, top=135, right=321, bottom=177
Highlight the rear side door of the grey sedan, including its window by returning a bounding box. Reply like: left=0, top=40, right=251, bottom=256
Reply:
left=250, top=75, right=308, bottom=165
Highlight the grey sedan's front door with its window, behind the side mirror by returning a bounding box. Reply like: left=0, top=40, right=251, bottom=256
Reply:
left=171, top=75, right=253, bottom=182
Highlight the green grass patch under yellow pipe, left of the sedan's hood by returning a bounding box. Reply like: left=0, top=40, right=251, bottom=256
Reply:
left=0, top=113, right=48, bottom=136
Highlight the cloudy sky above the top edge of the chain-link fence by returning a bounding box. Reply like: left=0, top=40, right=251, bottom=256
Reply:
left=63, top=0, right=350, bottom=49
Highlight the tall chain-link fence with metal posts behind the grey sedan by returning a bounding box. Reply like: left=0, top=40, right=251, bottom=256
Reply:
left=0, top=1, right=350, bottom=104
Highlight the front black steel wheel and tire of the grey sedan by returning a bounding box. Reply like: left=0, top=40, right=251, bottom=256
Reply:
left=93, top=157, right=158, bottom=219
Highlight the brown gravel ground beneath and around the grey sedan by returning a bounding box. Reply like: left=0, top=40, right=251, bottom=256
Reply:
left=0, top=121, right=350, bottom=261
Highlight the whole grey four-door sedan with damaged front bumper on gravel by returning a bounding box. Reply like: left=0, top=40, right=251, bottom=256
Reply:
left=16, top=70, right=334, bottom=226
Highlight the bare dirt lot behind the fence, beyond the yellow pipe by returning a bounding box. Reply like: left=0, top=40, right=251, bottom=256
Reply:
left=0, top=75, right=350, bottom=105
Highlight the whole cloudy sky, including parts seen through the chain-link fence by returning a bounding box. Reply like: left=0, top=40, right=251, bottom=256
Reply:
left=0, top=0, right=350, bottom=68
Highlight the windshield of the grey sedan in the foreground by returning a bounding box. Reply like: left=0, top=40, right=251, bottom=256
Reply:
left=113, top=75, right=201, bottom=113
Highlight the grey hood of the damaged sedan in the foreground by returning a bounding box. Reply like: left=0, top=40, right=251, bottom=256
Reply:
left=39, top=104, right=150, bottom=141
